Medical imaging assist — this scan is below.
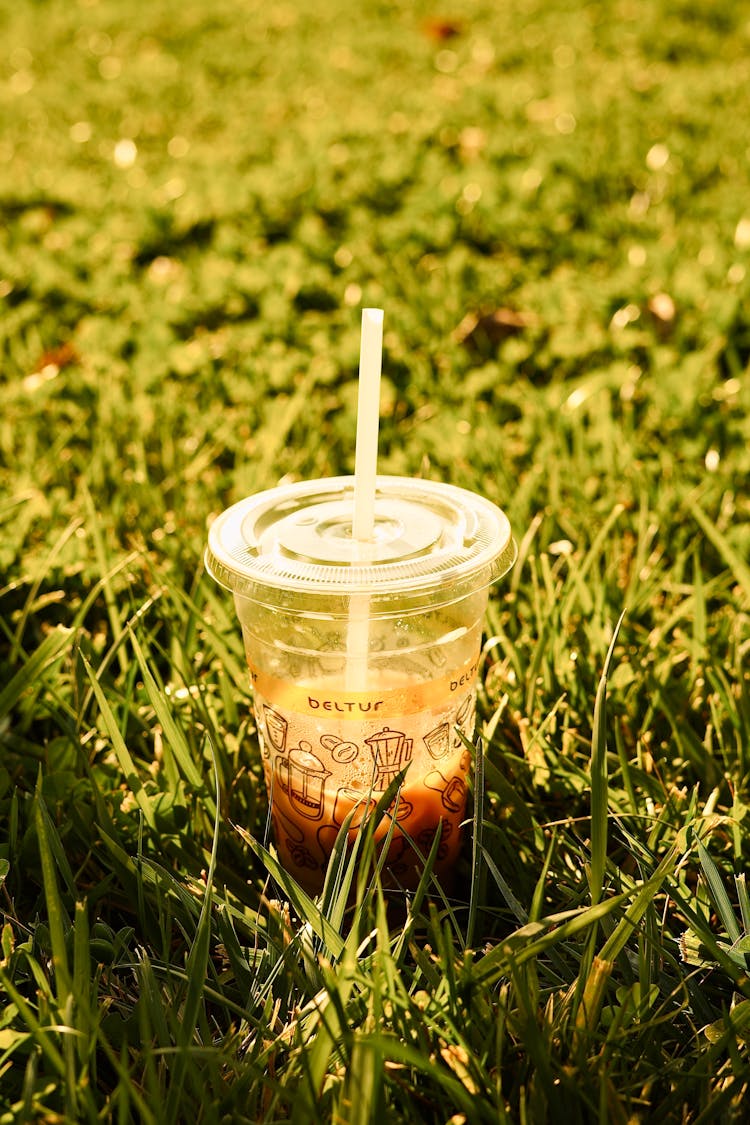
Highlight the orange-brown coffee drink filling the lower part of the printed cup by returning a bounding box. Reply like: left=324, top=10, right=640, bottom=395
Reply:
left=251, top=659, right=477, bottom=889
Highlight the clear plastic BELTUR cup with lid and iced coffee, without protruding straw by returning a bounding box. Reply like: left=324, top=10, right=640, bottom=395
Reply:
left=206, top=476, right=516, bottom=892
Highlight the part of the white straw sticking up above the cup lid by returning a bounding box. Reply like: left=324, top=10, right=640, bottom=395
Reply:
left=352, top=308, right=382, bottom=543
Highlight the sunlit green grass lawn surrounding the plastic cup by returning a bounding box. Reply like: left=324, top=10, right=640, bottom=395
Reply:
left=0, top=0, right=750, bottom=1125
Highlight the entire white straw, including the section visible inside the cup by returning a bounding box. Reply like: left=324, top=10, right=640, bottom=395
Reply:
left=345, top=308, right=382, bottom=692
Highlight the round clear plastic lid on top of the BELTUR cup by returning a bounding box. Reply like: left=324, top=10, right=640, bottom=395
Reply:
left=206, top=477, right=516, bottom=600
